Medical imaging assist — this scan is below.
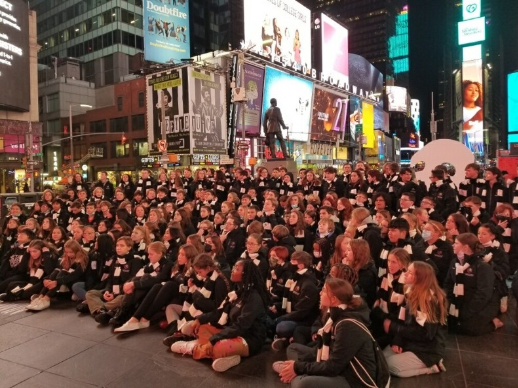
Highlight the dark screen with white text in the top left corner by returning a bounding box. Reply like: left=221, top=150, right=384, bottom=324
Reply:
left=0, top=0, right=31, bottom=111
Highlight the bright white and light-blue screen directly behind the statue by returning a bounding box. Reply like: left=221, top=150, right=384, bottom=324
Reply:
left=261, top=67, right=313, bottom=141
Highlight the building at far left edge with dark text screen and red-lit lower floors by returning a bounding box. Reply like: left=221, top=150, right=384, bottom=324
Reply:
left=0, top=5, right=41, bottom=193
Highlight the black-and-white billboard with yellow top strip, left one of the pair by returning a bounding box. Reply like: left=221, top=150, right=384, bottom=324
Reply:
left=146, top=67, right=192, bottom=155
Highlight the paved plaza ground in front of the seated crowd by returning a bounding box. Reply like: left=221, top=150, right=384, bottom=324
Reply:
left=0, top=300, right=518, bottom=388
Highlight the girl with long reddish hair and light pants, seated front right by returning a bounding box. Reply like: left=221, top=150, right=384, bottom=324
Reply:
left=383, top=261, right=447, bottom=377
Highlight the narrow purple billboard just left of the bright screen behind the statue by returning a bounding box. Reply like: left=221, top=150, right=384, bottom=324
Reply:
left=236, top=63, right=264, bottom=137
